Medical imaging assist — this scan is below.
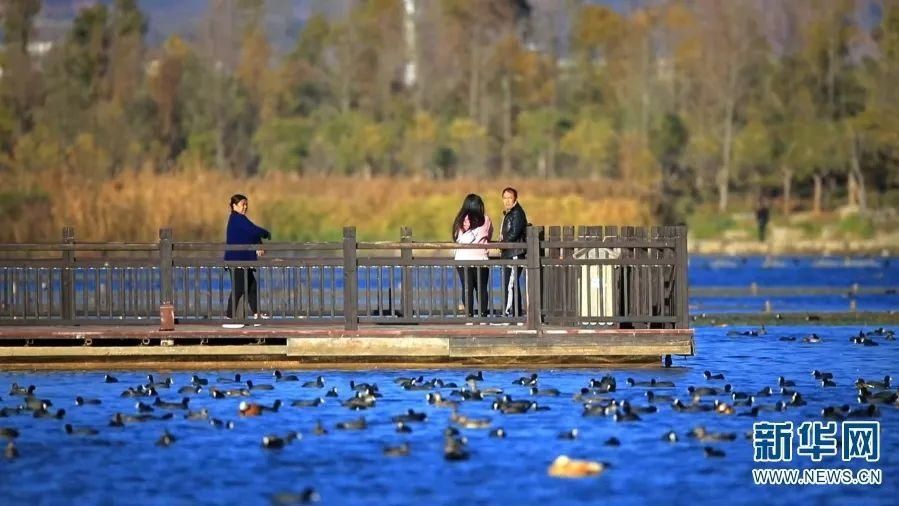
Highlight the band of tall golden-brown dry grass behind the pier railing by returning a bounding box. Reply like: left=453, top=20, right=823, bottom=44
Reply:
left=7, top=170, right=651, bottom=242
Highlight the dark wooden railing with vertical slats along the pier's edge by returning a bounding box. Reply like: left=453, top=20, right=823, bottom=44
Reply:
left=0, top=227, right=688, bottom=330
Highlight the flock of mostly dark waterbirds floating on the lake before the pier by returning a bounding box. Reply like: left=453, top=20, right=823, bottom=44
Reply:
left=0, top=328, right=899, bottom=502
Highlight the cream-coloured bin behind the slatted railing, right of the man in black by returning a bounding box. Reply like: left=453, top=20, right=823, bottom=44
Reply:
left=574, top=248, right=621, bottom=325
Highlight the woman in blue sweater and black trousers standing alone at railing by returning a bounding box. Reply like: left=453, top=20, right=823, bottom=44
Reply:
left=225, top=194, right=272, bottom=318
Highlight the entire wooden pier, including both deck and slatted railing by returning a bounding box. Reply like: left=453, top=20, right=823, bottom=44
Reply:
left=0, top=226, right=693, bottom=369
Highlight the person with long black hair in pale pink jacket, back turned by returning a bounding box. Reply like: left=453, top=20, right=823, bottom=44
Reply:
left=453, top=193, right=493, bottom=317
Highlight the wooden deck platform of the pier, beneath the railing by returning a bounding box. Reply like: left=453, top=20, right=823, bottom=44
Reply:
left=0, top=324, right=693, bottom=369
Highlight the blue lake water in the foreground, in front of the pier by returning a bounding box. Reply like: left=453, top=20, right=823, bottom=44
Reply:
left=0, top=327, right=899, bottom=505
